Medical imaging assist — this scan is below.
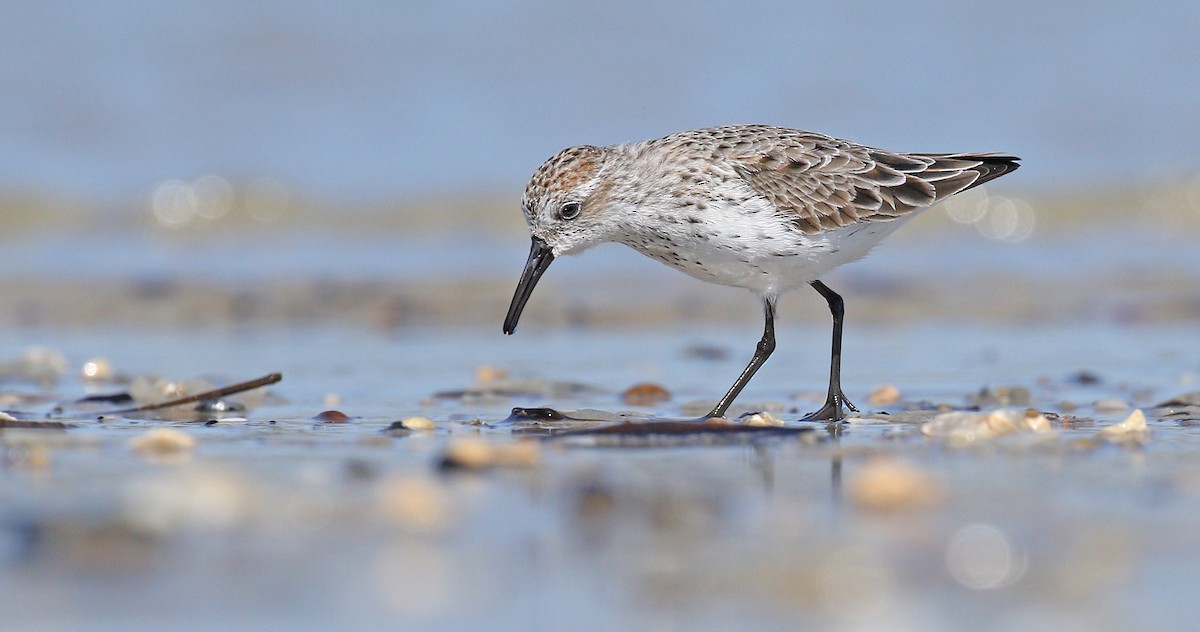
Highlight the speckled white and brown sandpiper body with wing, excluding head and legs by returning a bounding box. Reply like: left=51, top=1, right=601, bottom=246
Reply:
left=607, top=125, right=1019, bottom=295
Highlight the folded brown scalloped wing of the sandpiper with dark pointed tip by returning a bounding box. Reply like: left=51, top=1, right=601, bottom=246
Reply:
left=733, top=134, right=1019, bottom=234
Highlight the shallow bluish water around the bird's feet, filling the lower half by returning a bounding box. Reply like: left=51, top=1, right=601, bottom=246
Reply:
left=0, top=325, right=1200, bottom=630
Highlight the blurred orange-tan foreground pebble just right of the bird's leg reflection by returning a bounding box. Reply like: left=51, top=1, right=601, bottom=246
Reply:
left=848, top=459, right=944, bottom=512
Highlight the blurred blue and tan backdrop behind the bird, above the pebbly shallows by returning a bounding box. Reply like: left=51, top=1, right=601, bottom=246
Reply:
left=0, top=0, right=1200, bottom=327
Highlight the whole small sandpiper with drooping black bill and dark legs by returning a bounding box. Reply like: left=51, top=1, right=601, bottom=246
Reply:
left=504, top=125, right=1019, bottom=421
